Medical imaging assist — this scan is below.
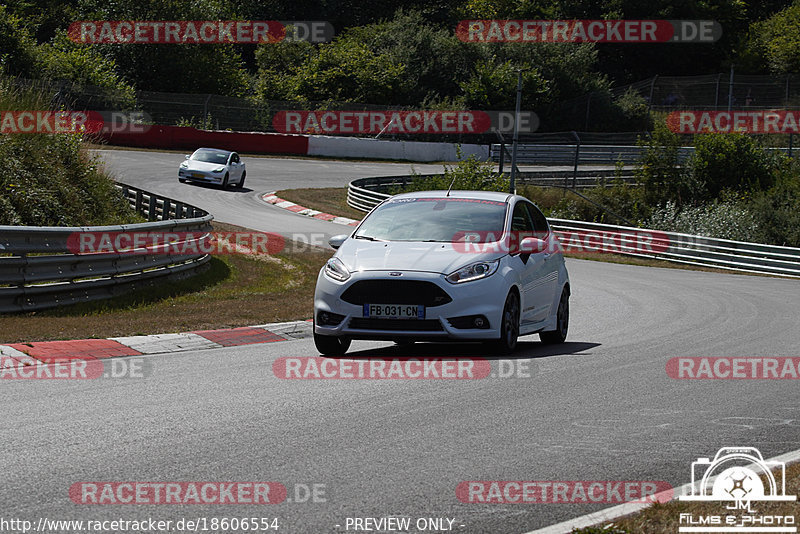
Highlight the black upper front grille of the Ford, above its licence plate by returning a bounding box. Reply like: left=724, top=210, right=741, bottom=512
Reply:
left=342, top=280, right=453, bottom=308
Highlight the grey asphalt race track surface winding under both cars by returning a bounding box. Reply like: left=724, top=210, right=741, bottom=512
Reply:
left=0, top=152, right=800, bottom=533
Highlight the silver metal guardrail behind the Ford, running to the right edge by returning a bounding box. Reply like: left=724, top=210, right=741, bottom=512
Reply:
left=347, top=175, right=800, bottom=278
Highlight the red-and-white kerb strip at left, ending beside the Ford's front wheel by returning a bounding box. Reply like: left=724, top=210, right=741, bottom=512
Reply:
left=0, top=319, right=311, bottom=367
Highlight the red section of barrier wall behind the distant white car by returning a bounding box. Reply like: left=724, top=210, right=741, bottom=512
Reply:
left=100, top=125, right=308, bottom=155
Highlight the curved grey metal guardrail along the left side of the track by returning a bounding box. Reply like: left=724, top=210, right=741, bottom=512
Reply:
left=0, top=184, right=213, bottom=313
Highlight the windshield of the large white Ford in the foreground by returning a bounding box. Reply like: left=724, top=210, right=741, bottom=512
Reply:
left=353, top=198, right=506, bottom=242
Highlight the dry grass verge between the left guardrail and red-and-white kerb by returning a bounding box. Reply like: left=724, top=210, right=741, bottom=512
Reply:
left=0, top=223, right=332, bottom=343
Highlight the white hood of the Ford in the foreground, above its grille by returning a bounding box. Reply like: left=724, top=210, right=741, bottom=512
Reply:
left=336, top=242, right=503, bottom=274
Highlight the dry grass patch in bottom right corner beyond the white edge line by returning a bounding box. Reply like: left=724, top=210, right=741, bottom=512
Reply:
left=572, top=463, right=800, bottom=534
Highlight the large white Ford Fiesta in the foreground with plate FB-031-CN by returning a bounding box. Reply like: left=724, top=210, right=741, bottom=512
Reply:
left=314, top=191, right=570, bottom=356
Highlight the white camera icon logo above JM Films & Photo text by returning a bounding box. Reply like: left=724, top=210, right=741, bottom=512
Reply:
left=679, top=447, right=797, bottom=502
